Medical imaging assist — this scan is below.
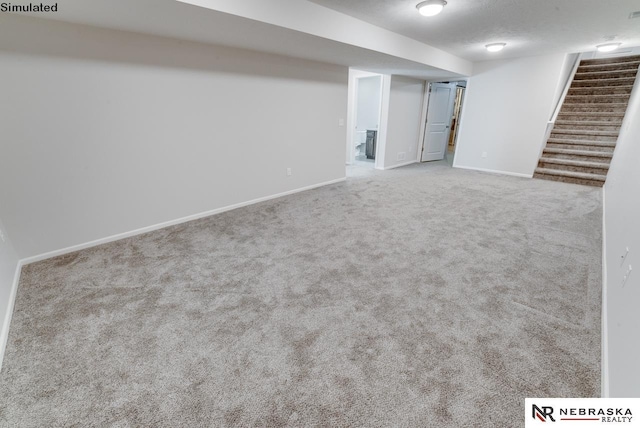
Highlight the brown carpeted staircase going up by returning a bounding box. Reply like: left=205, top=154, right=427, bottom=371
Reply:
left=533, top=55, right=640, bottom=187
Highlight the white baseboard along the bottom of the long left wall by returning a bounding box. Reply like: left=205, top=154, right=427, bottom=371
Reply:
left=20, top=177, right=346, bottom=265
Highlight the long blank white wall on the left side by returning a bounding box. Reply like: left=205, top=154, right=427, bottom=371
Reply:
left=0, top=14, right=348, bottom=258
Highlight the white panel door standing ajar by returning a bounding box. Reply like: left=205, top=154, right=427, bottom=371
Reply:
left=422, top=83, right=456, bottom=162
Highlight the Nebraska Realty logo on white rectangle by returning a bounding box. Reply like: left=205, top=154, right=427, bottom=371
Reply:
left=525, top=398, right=640, bottom=428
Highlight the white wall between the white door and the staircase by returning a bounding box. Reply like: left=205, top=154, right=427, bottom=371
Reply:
left=454, top=54, right=565, bottom=176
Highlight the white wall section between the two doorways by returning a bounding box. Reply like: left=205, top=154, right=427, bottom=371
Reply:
left=378, top=76, right=424, bottom=169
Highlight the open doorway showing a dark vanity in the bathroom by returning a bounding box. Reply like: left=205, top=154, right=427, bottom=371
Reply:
left=347, top=71, right=382, bottom=169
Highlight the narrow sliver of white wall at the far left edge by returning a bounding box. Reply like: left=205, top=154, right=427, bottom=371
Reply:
left=0, top=220, right=19, bottom=369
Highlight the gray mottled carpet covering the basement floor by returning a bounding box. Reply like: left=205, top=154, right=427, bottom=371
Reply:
left=0, top=163, right=601, bottom=427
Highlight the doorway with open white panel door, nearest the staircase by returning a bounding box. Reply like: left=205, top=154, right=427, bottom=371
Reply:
left=420, top=81, right=467, bottom=166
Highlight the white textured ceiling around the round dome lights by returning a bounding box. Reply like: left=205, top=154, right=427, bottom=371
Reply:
left=310, top=0, right=640, bottom=61
